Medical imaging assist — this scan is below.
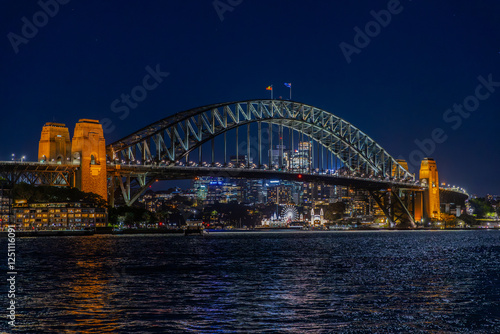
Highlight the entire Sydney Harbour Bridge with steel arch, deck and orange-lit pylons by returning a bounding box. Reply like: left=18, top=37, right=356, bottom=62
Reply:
left=0, top=99, right=468, bottom=227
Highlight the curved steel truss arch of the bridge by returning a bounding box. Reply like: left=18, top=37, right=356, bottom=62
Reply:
left=107, top=99, right=414, bottom=179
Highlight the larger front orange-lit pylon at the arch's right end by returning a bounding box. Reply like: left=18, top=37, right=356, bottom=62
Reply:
left=420, top=158, right=441, bottom=219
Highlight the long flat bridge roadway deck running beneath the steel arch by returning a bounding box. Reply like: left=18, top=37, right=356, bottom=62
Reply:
left=0, top=161, right=468, bottom=199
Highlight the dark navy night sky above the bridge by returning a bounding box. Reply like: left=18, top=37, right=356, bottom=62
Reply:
left=0, top=0, right=500, bottom=196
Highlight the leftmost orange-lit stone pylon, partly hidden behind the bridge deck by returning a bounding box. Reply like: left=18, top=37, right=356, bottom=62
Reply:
left=38, top=123, right=71, bottom=164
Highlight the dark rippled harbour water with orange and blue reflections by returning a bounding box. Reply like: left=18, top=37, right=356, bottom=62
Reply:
left=0, top=231, right=500, bottom=333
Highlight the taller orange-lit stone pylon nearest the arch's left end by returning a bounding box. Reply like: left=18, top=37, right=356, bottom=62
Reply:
left=71, top=119, right=108, bottom=200
